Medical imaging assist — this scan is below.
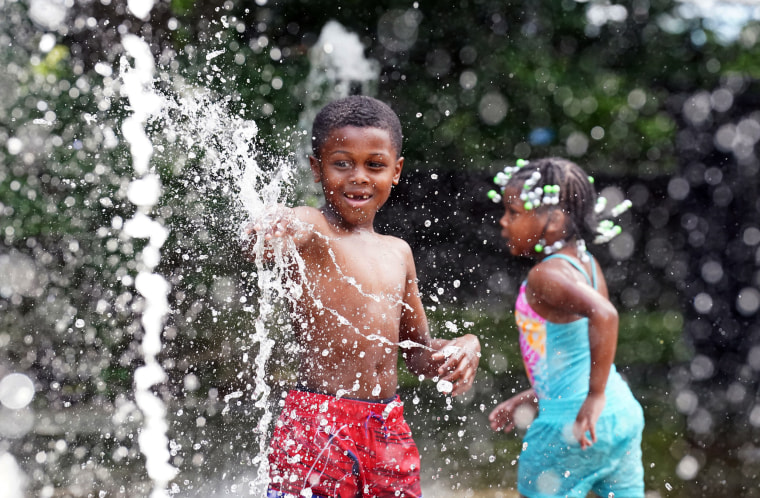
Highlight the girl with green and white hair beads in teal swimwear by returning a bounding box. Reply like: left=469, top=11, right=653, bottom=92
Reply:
left=489, top=158, right=644, bottom=498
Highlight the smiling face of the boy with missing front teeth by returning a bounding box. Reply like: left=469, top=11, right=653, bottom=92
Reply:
left=309, top=126, right=404, bottom=226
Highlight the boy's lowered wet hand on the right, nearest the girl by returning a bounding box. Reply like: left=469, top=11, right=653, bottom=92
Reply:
left=433, top=334, right=480, bottom=396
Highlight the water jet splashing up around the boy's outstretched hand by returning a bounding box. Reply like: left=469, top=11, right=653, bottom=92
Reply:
left=150, top=88, right=301, bottom=496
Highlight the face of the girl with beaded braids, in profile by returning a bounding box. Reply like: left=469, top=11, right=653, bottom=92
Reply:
left=499, top=186, right=547, bottom=256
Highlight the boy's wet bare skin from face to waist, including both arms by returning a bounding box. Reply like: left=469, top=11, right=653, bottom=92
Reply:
left=246, top=126, right=480, bottom=400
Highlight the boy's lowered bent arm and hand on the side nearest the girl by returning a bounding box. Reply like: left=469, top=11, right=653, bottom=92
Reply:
left=399, top=245, right=480, bottom=396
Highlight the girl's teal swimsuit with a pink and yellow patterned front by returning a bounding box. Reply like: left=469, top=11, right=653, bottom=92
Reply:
left=515, top=254, right=644, bottom=498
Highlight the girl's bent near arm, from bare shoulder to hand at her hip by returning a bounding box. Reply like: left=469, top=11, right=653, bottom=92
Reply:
left=528, top=260, right=618, bottom=448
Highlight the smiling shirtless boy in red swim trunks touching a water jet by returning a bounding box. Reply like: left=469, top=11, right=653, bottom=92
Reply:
left=249, top=96, right=480, bottom=497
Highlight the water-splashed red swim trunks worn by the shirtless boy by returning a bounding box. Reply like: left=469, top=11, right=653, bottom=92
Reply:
left=267, top=391, right=422, bottom=498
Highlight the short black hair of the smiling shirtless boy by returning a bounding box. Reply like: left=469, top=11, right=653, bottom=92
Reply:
left=311, top=95, right=403, bottom=157
